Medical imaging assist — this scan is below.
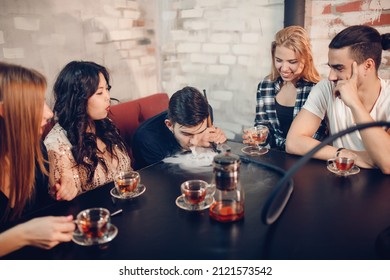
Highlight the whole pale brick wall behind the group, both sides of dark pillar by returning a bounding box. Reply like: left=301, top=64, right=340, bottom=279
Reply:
left=0, top=0, right=390, bottom=138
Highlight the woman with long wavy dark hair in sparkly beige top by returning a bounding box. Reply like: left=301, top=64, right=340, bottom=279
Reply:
left=44, top=61, right=131, bottom=200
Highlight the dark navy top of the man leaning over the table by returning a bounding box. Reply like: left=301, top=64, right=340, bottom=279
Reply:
left=132, top=111, right=181, bottom=169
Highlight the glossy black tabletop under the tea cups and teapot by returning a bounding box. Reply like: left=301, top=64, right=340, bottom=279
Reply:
left=6, top=142, right=390, bottom=260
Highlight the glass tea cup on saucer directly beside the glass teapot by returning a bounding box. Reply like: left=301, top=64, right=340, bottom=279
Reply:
left=180, top=180, right=215, bottom=206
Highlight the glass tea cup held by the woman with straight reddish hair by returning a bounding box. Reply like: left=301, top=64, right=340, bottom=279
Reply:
left=76, top=208, right=111, bottom=241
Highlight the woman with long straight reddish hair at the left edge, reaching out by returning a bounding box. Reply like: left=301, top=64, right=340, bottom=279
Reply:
left=0, top=62, right=75, bottom=256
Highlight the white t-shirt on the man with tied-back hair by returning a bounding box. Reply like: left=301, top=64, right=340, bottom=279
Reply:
left=303, top=79, right=390, bottom=151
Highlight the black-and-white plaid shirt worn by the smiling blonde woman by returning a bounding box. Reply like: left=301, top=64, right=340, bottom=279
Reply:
left=255, top=77, right=328, bottom=150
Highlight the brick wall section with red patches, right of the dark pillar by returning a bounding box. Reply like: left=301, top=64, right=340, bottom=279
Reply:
left=305, top=0, right=390, bottom=78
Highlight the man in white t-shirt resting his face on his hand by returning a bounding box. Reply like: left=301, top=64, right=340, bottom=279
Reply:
left=286, top=25, right=390, bottom=174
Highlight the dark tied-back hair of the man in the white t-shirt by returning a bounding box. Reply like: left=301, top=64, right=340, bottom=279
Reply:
left=329, top=25, right=390, bottom=70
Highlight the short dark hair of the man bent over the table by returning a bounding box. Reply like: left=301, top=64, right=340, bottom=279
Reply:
left=168, top=86, right=209, bottom=127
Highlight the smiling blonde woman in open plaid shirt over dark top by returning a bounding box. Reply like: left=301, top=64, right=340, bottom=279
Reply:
left=243, top=26, right=327, bottom=150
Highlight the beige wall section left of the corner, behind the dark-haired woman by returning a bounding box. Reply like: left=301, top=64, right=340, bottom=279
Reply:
left=0, top=0, right=160, bottom=103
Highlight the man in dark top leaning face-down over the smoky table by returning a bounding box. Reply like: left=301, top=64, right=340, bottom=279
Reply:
left=132, top=86, right=226, bottom=169
